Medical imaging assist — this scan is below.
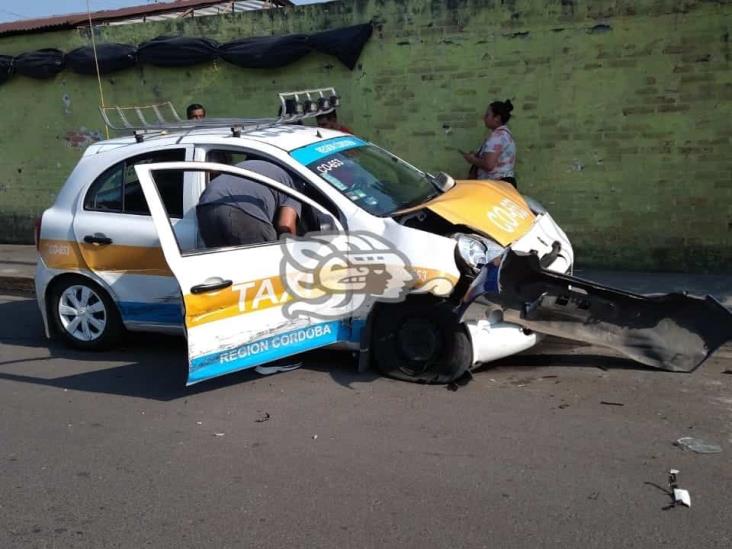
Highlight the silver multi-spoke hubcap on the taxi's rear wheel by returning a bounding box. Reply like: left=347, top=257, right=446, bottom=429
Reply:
left=58, top=285, right=107, bottom=341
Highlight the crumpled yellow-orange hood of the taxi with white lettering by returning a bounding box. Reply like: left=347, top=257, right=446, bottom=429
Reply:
left=423, top=180, right=535, bottom=246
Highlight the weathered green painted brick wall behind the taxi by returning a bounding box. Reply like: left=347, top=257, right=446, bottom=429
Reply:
left=0, top=0, right=732, bottom=272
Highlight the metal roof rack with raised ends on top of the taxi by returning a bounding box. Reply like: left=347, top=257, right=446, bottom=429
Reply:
left=99, top=88, right=340, bottom=142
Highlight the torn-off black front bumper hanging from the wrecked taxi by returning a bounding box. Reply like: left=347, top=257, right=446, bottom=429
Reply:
left=459, top=250, right=732, bottom=372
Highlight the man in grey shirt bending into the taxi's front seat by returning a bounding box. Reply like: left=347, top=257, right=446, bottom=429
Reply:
left=196, top=160, right=301, bottom=248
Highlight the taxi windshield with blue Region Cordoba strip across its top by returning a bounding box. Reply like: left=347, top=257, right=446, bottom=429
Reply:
left=292, top=137, right=438, bottom=216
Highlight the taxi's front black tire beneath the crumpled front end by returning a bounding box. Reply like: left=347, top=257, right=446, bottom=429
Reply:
left=371, top=298, right=473, bottom=383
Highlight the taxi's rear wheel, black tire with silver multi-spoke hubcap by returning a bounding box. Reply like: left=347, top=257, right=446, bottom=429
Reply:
left=48, top=276, right=124, bottom=350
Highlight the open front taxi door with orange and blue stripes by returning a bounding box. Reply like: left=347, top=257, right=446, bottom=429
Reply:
left=136, top=162, right=351, bottom=385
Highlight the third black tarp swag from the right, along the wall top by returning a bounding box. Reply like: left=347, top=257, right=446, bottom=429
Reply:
left=137, top=36, right=219, bottom=67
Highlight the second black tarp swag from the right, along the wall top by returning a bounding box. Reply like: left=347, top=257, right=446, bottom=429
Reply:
left=219, top=34, right=310, bottom=69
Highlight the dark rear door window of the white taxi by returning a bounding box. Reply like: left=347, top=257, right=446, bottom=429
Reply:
left=84, top=149, right=185, bottom=218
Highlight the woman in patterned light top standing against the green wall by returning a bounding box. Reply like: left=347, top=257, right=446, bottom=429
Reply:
left=463, top=99, right=516, bottom=187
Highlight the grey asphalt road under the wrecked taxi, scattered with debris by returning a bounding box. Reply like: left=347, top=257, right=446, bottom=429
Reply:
left=0, top=297, right=732, bottom=548
